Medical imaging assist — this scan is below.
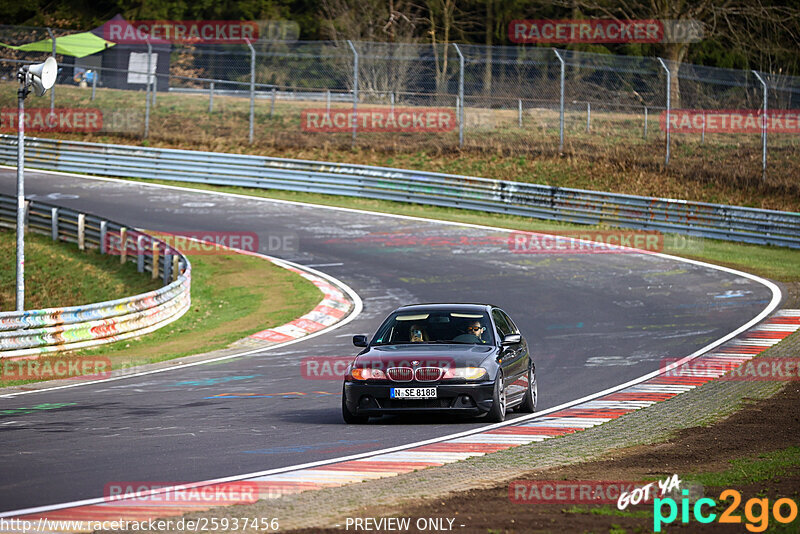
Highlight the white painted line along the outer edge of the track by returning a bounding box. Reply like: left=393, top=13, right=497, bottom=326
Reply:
left=0, top=165, right=782, bottom=517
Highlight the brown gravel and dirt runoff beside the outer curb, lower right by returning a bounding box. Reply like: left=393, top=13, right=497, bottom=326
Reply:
left=109, top=298, right=800, bottom=533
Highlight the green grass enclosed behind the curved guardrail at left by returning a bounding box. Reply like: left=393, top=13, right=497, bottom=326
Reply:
left=0, top=230, right=161, bottom=311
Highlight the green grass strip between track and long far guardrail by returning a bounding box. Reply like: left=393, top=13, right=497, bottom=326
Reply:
left=111, top=180, right=800, bottom=282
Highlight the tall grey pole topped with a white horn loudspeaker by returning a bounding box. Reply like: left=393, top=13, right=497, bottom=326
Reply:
left=17, top=57, right=58, bottom=311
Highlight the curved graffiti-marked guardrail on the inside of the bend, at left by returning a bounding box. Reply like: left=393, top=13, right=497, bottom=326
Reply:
left=0, top=195, right=191, bottom=359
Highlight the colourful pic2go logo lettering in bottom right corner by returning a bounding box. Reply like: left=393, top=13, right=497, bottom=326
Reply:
left=653, top=489, right=797, bottom=532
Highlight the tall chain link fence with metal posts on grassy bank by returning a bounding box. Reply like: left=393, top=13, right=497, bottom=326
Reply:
left=0, top=27, right=800, bottom=187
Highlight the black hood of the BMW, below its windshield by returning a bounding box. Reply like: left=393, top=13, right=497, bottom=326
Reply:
left=353, top=344, right=498, bottom=369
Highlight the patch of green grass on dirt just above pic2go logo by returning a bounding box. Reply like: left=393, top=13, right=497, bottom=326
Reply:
left=687, top=447, right=800, bottom=487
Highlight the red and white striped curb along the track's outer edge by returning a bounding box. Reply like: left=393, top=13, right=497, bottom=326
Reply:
left=0, top=310, right=800, bottom=531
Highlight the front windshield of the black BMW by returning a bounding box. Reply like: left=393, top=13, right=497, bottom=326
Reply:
left=373, top=310, right=494, bottom=345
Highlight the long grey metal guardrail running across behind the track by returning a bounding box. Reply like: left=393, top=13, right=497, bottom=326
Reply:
left=0, top=135, right=800, bottom=248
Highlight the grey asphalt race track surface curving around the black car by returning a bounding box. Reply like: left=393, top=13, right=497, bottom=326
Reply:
left=0, top=169, right=772, bottom=512
